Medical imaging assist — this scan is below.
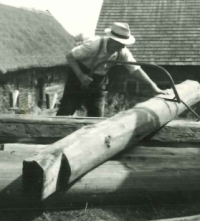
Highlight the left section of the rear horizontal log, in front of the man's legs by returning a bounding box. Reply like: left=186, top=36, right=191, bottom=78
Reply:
left=0, top=114, right=105, bottom=144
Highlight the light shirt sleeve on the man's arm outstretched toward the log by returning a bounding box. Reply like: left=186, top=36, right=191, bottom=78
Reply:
left=119, top=48, right=141, bottom=72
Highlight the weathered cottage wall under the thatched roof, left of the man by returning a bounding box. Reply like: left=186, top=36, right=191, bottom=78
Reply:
left=0, top=67, right=68, bottom=112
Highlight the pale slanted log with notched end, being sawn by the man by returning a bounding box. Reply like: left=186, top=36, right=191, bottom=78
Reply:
left=23, top=81, right=200, bottom=199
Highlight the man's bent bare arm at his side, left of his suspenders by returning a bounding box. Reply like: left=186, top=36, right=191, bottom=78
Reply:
left=66, top=52, right=93, bottom=86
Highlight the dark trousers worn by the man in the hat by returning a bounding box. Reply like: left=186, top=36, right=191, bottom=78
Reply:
left=57, top=64, right=108, bottom=117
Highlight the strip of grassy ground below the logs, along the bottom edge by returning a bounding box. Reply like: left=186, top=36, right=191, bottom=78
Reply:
left=0, top=204, right=200, bottom=221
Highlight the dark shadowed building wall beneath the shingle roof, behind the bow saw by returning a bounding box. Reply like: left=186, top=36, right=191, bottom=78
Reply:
left=91, top=65, right=200, bottom=94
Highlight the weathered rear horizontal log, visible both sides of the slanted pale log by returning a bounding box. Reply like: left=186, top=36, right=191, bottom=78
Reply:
left=0, top=114, right=200, bottom=145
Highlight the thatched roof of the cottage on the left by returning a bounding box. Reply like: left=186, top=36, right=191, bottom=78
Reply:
left=0, top=4, right=74, bottom=73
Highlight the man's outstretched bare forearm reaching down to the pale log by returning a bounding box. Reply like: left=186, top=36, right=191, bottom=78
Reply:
left=130, top=68, right=166, bottom=95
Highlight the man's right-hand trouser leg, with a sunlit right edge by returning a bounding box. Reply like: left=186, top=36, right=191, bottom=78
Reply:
left=86, top=91, right=106, bottom=117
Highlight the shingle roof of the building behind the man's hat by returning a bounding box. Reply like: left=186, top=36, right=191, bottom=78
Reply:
left=96, top=0, right=200, bottom=65
